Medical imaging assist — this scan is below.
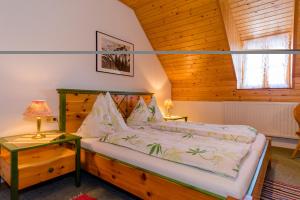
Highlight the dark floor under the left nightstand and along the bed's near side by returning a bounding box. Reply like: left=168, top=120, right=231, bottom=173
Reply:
left=0, top=172, right=137, bottom=200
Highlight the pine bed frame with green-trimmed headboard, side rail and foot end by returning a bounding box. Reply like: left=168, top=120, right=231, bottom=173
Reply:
left=57, top=89, right=271, bottom=200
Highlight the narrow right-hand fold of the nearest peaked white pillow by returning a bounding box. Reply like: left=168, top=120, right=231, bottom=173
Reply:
left=105, top=92, right=128, bottom=131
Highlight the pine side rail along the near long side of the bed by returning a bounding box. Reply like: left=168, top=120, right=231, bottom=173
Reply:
left=81, top=149, right=230, bottom=200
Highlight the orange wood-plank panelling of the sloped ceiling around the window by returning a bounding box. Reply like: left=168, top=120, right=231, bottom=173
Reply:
left=120, top=0, right=300, bottom=101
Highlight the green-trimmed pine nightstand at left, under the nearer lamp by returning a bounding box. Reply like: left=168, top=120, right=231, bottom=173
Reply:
left=0, top=132, right=81, bottom=200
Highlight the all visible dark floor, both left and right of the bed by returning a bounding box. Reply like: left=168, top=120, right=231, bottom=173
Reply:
left=0, top=147, right=300, bottom=200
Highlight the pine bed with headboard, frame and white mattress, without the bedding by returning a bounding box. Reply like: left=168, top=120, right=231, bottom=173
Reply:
left=58, top=89, right=270, bottom=199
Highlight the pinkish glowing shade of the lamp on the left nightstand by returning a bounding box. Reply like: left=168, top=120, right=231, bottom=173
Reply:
left=24, top=100, right=52, bottom=117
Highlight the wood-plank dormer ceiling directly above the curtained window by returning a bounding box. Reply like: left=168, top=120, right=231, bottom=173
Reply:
left=228, top=0, right=295, bottom=40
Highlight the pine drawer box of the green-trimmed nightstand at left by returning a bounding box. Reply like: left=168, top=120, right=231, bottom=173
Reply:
left=1, top=145, right=75, bottom=189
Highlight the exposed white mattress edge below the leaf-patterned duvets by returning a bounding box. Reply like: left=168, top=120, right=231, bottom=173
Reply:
left=81, top=134, right=266, bottom=199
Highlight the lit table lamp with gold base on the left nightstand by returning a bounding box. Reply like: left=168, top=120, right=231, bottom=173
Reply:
left=24, top=100, right=52, bottom=139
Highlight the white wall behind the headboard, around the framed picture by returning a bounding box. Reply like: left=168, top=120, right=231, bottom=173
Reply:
left=0, top=0, right=171, bottom=136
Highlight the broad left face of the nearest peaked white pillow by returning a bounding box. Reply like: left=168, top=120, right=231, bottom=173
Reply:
left=77, top=94, right=115, bottom=137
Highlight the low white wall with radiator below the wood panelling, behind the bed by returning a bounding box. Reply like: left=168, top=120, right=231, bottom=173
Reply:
left=172, top=101, right=299, bottom=148
